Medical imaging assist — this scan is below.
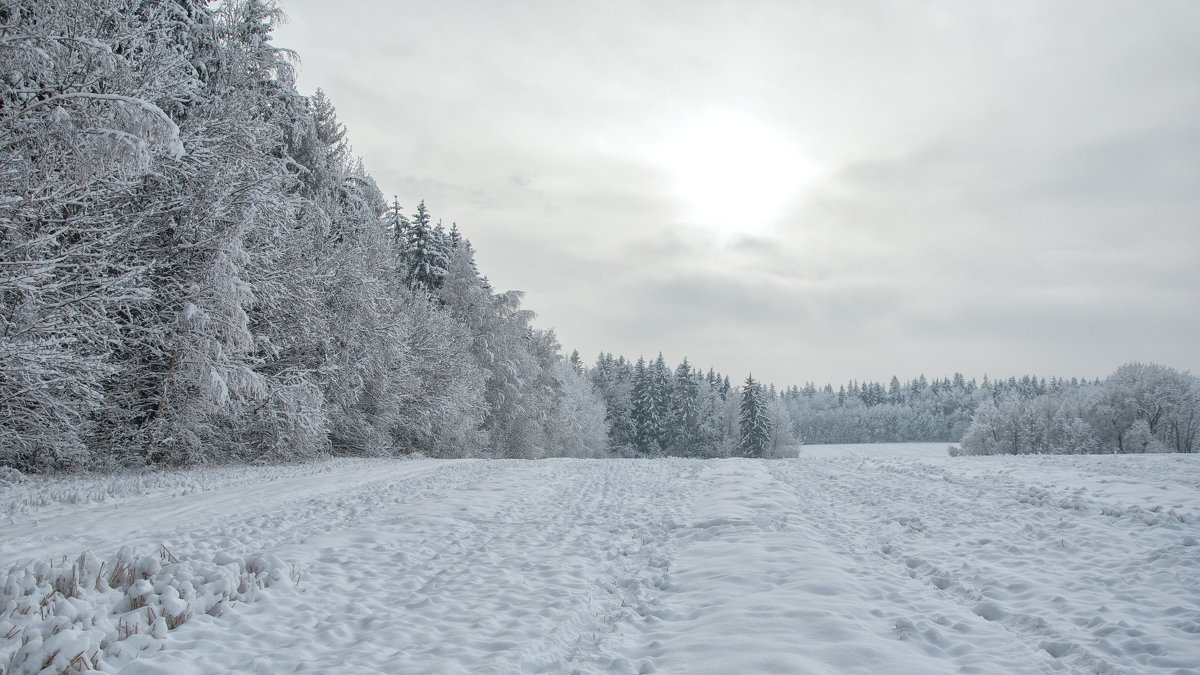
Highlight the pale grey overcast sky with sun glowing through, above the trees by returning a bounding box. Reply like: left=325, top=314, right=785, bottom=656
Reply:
left=275, top=0, right=1200, bottom=386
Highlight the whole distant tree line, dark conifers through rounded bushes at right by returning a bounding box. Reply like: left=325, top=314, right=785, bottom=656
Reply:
left=585, top=353, right=1200, bottom=456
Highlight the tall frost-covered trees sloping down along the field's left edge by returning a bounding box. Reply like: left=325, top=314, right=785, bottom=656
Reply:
left=0, top=0, right=606, bottom=470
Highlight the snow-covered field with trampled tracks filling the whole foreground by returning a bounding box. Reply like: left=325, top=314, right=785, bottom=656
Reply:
left=0, top=443, right=1200, bottom=674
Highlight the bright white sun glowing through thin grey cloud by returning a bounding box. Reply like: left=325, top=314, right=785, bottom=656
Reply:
left=649, top=110, right=816, bottom=238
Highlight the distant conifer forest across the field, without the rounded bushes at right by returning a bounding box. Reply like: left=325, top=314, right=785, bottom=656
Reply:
left=580, top=353, right=1113, bottom=458
